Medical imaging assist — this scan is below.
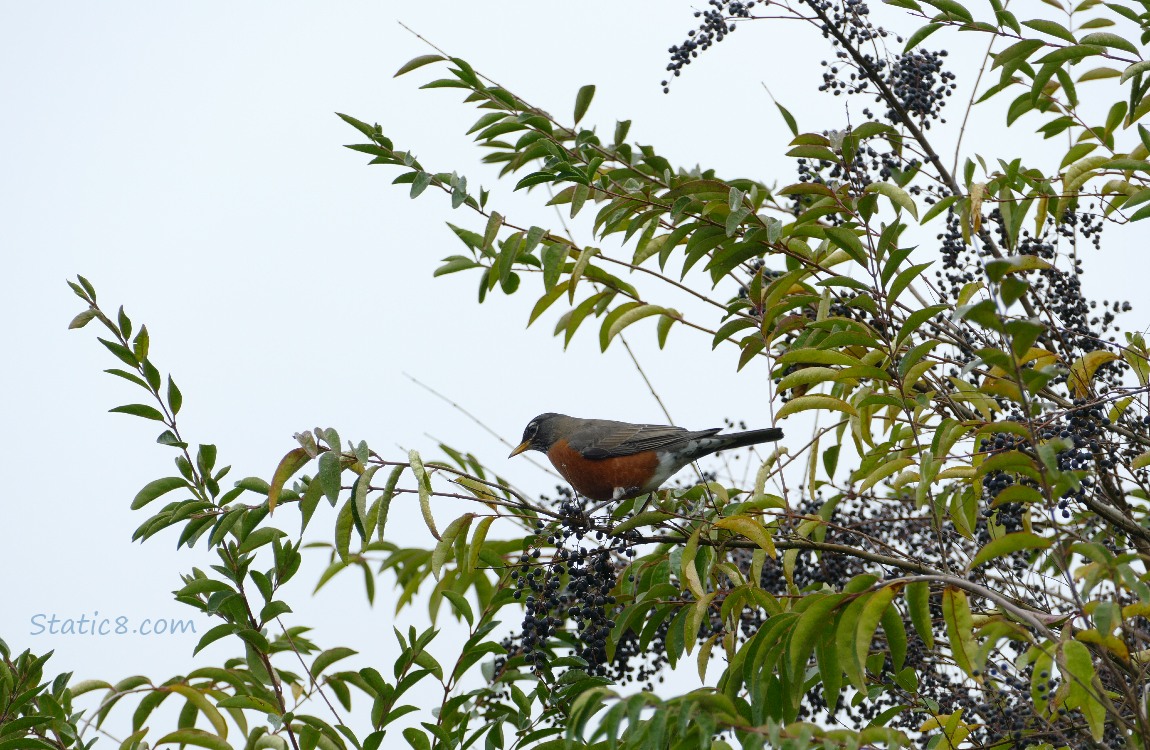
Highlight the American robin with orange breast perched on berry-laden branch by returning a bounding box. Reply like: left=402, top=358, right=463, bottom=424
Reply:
left=507, top=413, right=783, bottom=502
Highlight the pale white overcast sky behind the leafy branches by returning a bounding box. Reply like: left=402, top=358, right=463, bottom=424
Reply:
left=0, top=0, right=1147, bottom=745
